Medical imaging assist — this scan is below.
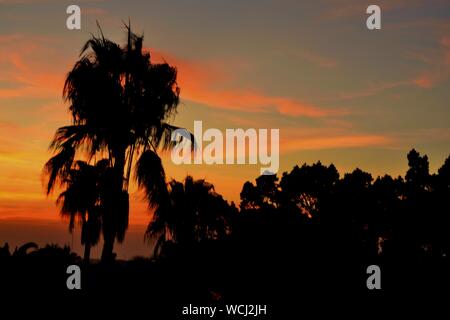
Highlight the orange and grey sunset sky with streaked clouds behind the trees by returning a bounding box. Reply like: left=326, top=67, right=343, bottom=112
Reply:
left=0, top=0, right=450, bottom=257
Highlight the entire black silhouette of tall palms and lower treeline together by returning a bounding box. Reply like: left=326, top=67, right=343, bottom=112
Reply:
left=0, top=25, right=450, bottom=312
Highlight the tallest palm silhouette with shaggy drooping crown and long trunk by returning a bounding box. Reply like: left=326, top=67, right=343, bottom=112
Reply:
left=42, top=25, right=190, bottom=261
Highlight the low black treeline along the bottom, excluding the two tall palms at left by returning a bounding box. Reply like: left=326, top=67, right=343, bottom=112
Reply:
left=0, top=150, right=450, bottom=304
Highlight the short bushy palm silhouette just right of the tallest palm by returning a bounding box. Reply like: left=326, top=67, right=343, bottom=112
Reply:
left=144, top=176, right=237, bottom=254
